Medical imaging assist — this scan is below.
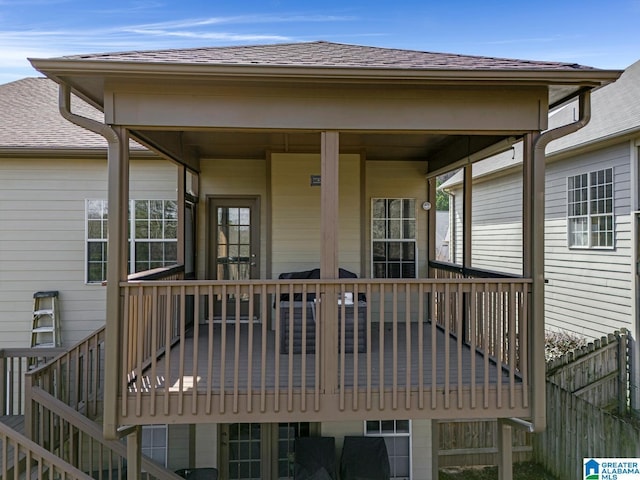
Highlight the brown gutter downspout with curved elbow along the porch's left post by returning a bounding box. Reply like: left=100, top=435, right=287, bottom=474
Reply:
left=58, top=85, right=122, bottom=440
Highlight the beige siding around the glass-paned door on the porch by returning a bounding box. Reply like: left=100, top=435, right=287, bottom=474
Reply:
left=197, top=159, right=268, bottom=278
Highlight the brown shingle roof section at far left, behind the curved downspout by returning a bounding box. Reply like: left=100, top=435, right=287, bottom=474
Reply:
left=0, top=78, right=107, bottom=150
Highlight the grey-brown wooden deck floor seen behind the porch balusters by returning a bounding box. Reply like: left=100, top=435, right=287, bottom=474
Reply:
left=138, top=322, right=520, bottom=391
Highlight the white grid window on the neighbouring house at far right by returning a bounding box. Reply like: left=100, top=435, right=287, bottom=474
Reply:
left=567, top=168, right=614, bottom=248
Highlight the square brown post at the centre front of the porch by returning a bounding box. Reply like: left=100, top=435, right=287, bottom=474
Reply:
left=320, top=132, right=339, bottom=394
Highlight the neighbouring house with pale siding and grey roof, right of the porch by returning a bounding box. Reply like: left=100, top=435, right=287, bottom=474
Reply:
left=443, top=58, right=640, bottom=339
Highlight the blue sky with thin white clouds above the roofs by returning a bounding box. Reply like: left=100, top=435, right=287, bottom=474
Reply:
left=0, top=0, right=640, bottom=83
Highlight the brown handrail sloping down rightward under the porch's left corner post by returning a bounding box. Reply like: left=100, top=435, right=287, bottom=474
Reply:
left=31, top=386, right=182, bottom=480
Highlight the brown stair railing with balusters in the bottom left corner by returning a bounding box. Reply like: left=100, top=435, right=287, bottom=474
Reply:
left=0, top=422, right=92, bottom=480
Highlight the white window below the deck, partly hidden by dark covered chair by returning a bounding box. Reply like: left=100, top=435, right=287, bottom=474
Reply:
left=364, top=420, right=411, bottom=480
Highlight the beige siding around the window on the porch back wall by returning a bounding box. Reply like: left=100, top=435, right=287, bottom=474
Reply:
left=363, top=161, right=428, bottom=277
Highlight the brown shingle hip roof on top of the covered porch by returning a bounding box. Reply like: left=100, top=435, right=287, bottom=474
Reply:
left=61, top=41, right=593, bottom=71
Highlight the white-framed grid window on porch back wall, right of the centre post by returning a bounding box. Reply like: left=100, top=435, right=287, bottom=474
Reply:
left=371, top=198, right=416, bottom=278
